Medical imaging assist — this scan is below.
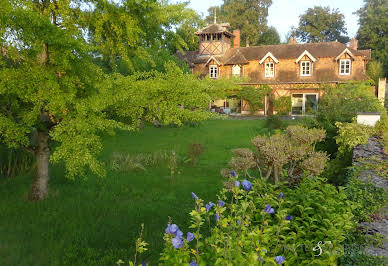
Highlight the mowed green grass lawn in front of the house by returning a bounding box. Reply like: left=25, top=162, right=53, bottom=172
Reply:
left=0, top=120, right=267, bottom=265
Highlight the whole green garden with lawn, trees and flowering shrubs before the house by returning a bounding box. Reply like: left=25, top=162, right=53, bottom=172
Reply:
left=0, top=0, right=388, bottom=266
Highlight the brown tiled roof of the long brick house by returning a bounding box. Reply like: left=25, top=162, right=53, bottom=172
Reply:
left=177, top=42, right=371, bottom=84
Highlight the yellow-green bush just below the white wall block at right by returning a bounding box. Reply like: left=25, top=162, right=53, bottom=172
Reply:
left=335, top=122, right=376, bottom=153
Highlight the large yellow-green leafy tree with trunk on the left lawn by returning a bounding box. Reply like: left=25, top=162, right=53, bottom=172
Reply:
left=0, top=0, right=230, bottom=200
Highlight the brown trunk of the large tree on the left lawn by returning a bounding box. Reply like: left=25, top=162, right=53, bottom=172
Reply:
left=28, top=132, right=50, bottom=201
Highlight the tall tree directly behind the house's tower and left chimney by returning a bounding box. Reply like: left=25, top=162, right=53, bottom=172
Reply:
left=206, top=0, right=272, bottom=45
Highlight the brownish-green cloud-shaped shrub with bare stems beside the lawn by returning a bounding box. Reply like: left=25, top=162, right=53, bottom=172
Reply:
left=230, top=126, right=327, bottom=184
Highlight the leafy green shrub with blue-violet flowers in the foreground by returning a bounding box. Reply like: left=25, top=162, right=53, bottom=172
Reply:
left=161, top=177, right=354, bottom=265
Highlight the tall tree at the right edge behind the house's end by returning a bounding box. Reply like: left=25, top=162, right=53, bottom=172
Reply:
left=357, top=0, right=388, bottom=75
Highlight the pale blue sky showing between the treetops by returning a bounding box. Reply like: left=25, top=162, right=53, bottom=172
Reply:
left=183, top=0, right=363, bottom=41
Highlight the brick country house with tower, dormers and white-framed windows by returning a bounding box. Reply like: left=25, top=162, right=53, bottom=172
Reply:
left=181, top=23, right=371, bottom=115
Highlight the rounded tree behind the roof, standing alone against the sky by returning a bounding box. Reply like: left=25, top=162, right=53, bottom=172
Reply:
left=294, top=6, right=349, bottom=43
